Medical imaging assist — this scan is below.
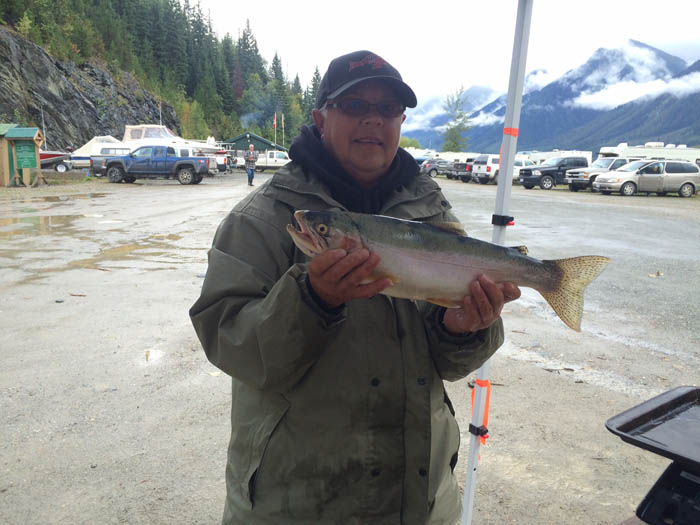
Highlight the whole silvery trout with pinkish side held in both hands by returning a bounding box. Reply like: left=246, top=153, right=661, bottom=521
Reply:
left=287, top=210, right=610, bottom=332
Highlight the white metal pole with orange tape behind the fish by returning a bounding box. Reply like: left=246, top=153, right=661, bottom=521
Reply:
left=461, top=0, right=534, bottom=525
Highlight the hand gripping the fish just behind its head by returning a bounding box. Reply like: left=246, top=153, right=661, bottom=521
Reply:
left=308, top=249, right=392, bottom=308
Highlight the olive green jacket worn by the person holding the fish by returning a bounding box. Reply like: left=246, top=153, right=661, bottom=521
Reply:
left=190, top=162, right=503, bottom=524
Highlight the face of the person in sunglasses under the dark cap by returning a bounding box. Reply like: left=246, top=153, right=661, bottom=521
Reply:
left=313, top=80, right=406, bottom=186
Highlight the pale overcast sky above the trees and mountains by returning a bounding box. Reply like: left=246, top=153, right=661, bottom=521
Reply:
left=206, top=0, right=700, bottom=105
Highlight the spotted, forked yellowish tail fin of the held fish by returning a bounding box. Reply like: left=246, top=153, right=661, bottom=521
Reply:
left=540, top=255, right=610, bottom=332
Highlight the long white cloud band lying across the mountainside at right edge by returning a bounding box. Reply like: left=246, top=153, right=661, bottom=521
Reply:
left=567, top=73, right=700, bottom=110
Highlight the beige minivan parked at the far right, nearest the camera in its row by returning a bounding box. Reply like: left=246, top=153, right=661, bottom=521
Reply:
left=593, top=159, right=700, bottom=197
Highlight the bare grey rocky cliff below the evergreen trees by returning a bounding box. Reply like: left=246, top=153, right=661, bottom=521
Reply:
left=0, top=26, right=179, bottom=149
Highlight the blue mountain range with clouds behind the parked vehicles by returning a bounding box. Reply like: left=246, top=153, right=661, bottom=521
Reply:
left=403, top=40, right=700, bottom=153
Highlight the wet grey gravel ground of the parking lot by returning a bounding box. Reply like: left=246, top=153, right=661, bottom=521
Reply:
left=0, top=172, right=700, bottom=524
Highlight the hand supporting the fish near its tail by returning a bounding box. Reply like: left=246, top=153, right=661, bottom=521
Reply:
left=442, top=275, right=520, bottom=334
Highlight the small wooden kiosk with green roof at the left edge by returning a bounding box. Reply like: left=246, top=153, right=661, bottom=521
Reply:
left=0, top=124, right=46, bottom=186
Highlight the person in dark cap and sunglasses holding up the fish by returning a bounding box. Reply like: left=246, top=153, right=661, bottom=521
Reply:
left=190, top=51, right=520, bottom=524
